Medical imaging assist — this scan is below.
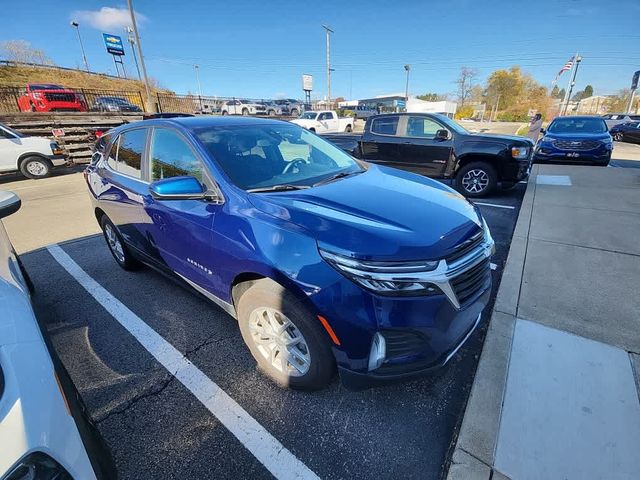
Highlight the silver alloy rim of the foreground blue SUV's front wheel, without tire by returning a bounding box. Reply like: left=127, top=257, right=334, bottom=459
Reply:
left=249, top=307, right=311, bottom=377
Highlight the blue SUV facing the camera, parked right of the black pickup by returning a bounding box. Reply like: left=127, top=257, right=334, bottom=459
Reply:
left=534, top=116, right=613, bottom=167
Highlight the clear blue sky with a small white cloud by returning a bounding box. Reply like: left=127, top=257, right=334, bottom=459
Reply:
left=0, top=0, right=640, bottom=98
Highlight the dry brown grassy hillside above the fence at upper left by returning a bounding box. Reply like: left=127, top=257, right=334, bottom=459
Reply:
left=0, top=61, right=172, bottom=93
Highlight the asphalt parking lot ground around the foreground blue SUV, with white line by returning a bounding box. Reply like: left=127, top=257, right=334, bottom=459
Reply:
left=0, top=164, right=525, bottom=479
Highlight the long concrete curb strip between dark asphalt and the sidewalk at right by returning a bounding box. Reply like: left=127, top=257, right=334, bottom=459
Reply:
left=447, top=165, right=539, bottom=480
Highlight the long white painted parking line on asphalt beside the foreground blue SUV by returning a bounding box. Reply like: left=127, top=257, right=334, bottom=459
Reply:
left=47, top=245, right=319, bottom=479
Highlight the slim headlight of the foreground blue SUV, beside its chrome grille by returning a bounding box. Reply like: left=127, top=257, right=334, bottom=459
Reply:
left=320, top=249, right=442, bottom=296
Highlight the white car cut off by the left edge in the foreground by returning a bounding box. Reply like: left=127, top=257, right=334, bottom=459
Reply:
left=0, top=191, right=117, bottom=480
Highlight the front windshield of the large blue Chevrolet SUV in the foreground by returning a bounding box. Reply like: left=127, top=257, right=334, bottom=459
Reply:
left=195, top=124, right=363, bottom=190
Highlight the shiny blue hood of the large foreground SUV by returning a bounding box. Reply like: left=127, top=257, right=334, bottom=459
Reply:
left=250, top=165, right=482, bottom=261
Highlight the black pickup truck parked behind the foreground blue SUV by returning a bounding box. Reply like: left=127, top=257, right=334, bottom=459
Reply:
left=323, top=113, right=534, bottom=197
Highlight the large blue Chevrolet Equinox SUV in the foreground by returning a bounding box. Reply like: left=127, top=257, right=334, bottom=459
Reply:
left=85, top=117, right=494, bottom=389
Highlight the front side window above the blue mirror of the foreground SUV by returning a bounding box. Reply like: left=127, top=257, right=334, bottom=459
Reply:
left=149, top=128, right=203, bottom=181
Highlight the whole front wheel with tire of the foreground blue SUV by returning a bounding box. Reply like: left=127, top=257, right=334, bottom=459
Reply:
left=236, top=278, right=336, bottom=390
